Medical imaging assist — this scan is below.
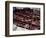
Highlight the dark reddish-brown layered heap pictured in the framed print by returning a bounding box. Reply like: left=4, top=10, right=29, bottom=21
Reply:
left=13, top=8, right=40, bottom=30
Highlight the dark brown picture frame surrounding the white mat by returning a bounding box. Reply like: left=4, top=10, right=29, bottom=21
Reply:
left=5, top=1, right=45, bottom=37
